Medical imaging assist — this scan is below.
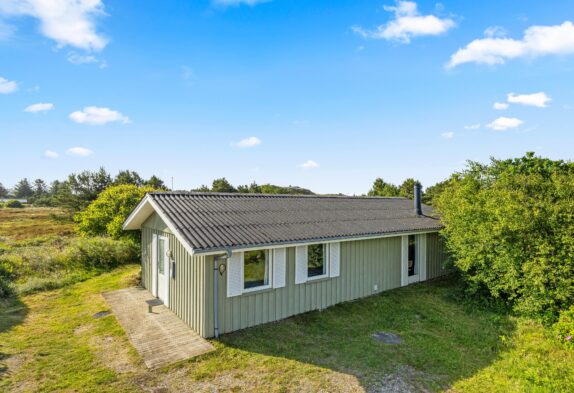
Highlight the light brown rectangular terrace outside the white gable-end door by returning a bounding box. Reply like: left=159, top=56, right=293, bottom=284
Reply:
left=103, top=288, right=214, bottom=368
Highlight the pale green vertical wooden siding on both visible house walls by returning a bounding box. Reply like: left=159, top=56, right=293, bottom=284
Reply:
left=142, top=213, right=447, bottom=337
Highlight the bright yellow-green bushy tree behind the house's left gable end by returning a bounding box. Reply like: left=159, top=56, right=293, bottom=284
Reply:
left=74, top=184, right=158, bottom=240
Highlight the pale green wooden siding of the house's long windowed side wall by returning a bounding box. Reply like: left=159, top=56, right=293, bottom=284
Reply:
left=206, top=237, right=401, bottom=333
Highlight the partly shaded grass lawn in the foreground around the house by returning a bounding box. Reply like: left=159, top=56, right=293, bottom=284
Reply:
left=0, top=265, right=574, bottom=392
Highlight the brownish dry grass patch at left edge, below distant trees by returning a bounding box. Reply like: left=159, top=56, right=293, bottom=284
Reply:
left=0, top=207, right=74, bottom=242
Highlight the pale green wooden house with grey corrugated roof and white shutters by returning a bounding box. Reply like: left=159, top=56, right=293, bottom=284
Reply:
left=124, top=189, right=446, bottom=337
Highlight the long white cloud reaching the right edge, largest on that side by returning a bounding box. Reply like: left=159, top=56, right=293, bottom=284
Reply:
left=447, top=21, right=574, bottom=68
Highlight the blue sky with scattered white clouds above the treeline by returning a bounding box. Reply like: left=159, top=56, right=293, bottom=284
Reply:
left=0, top=0, right=574, bottom=194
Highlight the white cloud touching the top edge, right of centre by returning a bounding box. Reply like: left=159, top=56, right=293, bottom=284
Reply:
left=352, top=1, right=456, bottom=44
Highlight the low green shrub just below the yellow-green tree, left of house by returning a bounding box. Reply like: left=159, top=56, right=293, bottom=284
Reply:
left=64, top=237, right=139, bottom=269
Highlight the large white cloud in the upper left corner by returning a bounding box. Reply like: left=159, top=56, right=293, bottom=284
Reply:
left=0, top=0, right=108, bottom=51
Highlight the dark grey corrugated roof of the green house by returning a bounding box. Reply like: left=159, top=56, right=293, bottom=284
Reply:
left=149, top=192, right=442, bottom=252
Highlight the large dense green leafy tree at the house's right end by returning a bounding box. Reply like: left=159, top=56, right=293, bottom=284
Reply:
left=436, top=153, right=574, bottom=322
